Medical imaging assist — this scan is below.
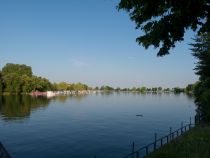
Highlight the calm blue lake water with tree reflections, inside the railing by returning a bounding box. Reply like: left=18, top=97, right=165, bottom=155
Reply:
left=0, top=93, right=196, bottom=158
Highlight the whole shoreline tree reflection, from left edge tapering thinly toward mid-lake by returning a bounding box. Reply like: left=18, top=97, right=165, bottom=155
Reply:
left=0, top=95, right=87, bottom=121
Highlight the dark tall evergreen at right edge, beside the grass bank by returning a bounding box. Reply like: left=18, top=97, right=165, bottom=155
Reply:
left=191, top=33, right=210, bottom=120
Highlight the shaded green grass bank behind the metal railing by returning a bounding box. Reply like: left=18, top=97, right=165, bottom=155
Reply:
left=147, top=124, right=210, bottom=158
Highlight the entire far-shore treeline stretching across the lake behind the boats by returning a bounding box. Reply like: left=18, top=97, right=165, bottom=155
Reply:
left=0, top=63, right=195, bottom=94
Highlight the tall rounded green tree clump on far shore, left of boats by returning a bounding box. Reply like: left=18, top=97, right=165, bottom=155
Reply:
left=0, top=64, right=51, bottom=94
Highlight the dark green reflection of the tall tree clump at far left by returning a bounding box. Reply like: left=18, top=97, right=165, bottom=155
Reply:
left=0, top=95, right=49, bottom=120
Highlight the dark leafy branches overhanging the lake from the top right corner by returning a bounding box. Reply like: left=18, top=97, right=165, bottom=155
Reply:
left=118, top=0, right=210, bottom=56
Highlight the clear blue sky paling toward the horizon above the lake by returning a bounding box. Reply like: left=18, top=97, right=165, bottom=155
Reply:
left=0, top=0, right=198, bottom=87
